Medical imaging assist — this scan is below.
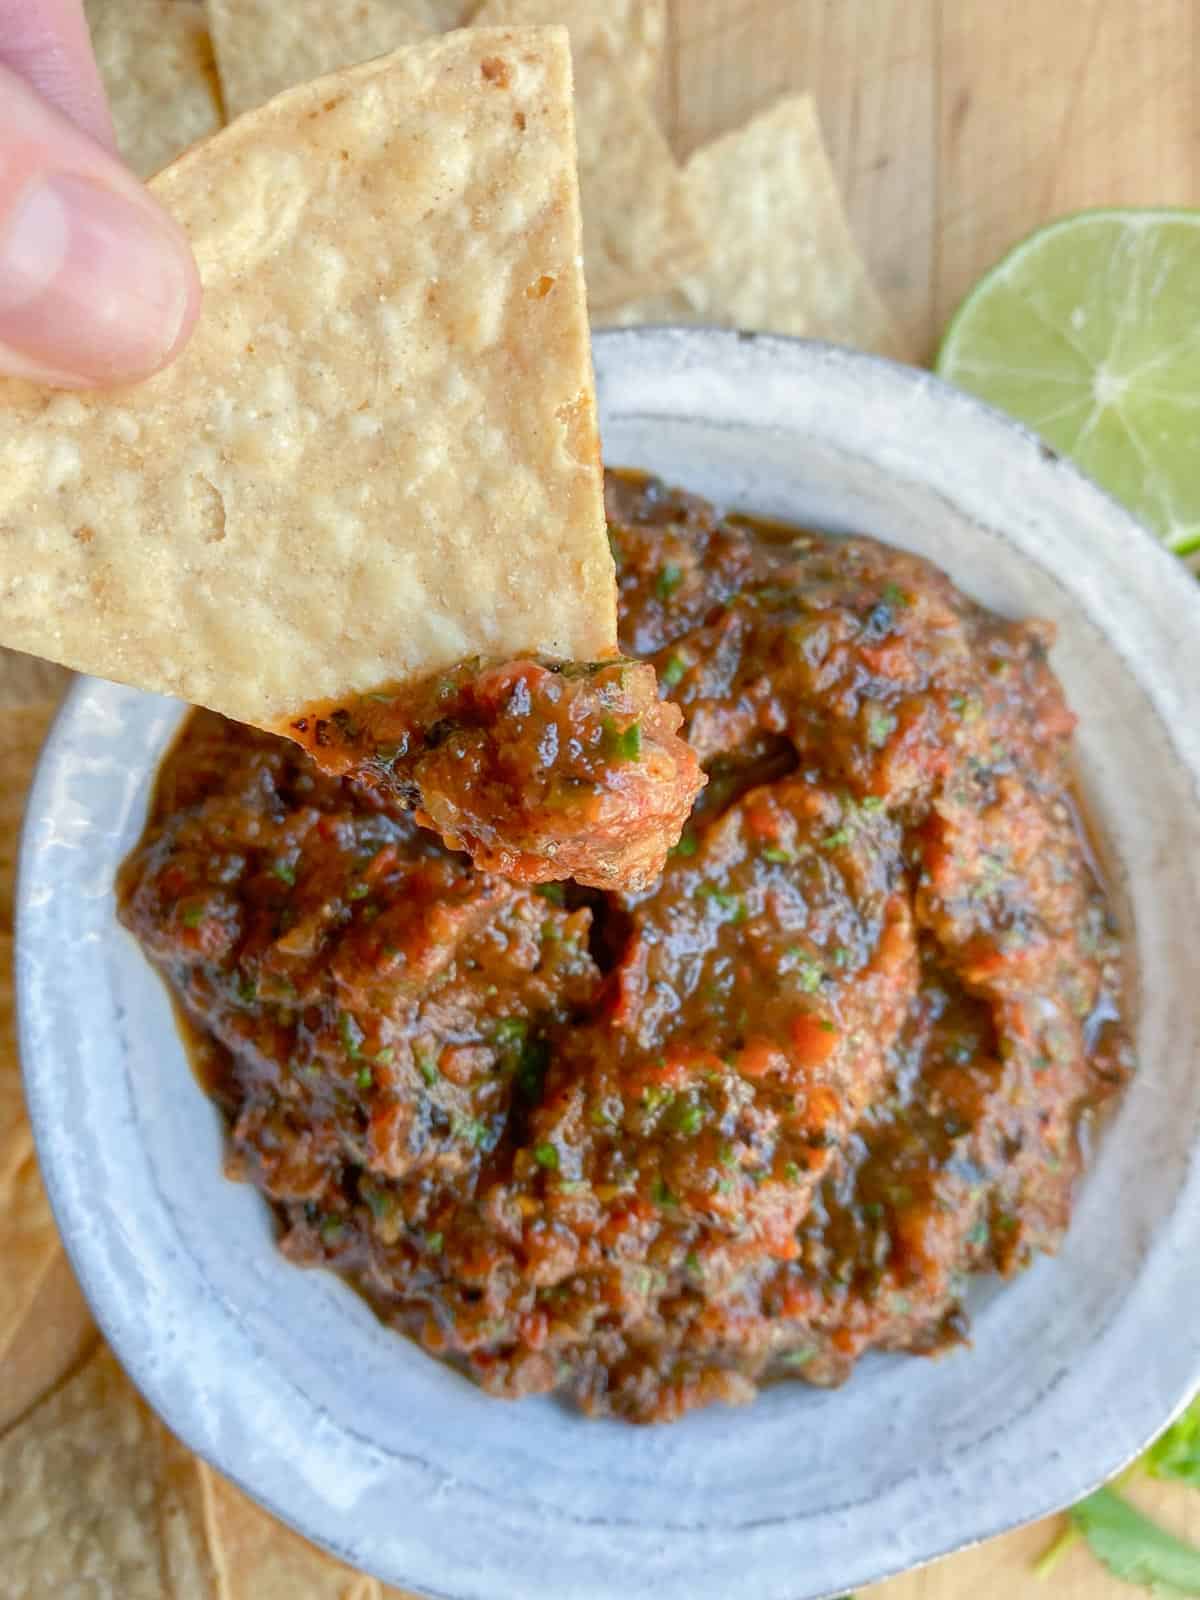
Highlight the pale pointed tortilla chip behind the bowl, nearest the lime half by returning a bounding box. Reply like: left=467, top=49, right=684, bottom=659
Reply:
left=608, top=94, right=904, bottom=355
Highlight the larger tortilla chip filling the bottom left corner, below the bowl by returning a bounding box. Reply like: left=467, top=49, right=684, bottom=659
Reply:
left=0, top=1349, right=218, bottom=1600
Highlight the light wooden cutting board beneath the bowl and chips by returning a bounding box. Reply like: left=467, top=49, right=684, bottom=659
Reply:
left=0, top=0, right=1200, bottom=1600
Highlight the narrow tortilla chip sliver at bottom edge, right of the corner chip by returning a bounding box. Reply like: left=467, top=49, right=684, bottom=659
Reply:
left=197, top=1461, right=379, bottom=1600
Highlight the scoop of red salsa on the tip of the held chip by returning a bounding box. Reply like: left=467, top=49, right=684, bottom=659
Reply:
left=285, top=659, right=704, bottom=890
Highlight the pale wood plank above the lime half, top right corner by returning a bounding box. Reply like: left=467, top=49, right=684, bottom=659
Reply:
left=933, top=0, right=1200, bottom=334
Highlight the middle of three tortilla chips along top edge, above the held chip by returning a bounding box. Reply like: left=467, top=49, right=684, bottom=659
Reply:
left=208, top=0, right=430, bottom=117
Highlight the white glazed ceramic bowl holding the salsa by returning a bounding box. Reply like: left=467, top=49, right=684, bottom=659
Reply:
left=18, top=330, right=1200, bottom=1600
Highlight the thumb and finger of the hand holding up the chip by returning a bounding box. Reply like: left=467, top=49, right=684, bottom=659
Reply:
left=0, top=0, right=200, bottom=389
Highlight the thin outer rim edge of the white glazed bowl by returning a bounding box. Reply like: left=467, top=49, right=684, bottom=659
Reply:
left=16, top=326, right=1200, bottom=1600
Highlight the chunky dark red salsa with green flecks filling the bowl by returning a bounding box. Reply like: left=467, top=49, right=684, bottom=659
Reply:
left=120, top=475, right=1131, bottom=1422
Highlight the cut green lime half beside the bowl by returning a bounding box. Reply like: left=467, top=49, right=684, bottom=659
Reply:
left=936, top=210, right=1200, bottom=555
